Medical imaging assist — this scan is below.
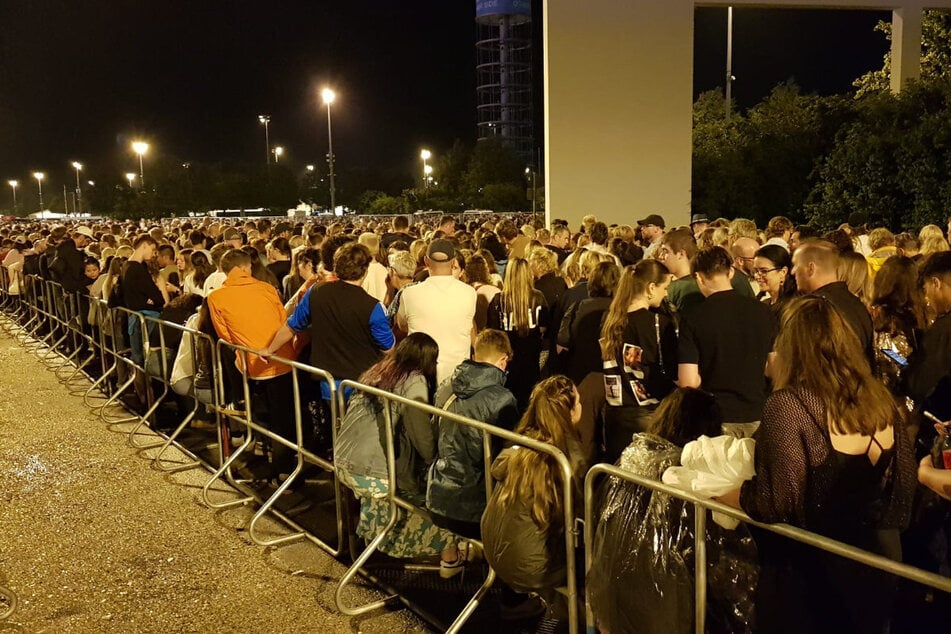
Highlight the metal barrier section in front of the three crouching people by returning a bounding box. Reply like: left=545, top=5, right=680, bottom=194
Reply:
left=334, top=381, right=578, bottom=634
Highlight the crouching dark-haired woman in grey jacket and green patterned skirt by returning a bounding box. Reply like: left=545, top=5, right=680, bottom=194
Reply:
left=334, top=332, right=458, bottom=564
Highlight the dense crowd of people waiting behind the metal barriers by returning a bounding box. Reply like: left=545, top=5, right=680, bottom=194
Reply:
left=0, top=214, right=951, bottom=632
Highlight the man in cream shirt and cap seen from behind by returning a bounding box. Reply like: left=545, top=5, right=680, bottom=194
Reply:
left=396, top=239, right=476, bottom=383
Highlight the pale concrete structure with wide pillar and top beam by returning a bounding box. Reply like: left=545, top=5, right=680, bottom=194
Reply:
left=543, top=0, right=951, bottom=232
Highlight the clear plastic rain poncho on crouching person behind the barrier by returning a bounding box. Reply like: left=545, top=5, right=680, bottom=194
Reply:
left=587, top=434, right=759, bottom=634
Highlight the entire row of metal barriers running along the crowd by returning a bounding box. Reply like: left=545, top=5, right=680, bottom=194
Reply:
left=0, top=267, right=951, bottom=634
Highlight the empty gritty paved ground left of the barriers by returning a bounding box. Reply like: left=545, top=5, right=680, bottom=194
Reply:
left=0, top=332, right=427, bottom=634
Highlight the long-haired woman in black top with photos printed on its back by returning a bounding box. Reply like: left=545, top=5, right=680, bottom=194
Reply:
left=600, top=260, right=677, bottom=463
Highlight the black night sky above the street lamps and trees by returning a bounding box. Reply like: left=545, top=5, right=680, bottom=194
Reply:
left=0, top=0, right=889, bottom=195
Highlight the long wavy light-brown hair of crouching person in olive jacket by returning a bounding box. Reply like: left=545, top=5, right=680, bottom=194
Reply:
left=496, top=375, right=580, bottom=530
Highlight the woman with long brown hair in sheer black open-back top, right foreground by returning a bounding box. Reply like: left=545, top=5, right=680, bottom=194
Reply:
left=725, top=296, right=916, bottom=632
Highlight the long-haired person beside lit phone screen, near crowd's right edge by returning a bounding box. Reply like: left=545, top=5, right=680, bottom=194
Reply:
left=869, top=256, right=927, bottom=396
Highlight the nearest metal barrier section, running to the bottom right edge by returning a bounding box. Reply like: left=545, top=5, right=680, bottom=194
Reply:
left=584, top=464, right=951, bottom=634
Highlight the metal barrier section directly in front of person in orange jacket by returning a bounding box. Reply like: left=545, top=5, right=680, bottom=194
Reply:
left=202, top=339, right=346, bottom=557
